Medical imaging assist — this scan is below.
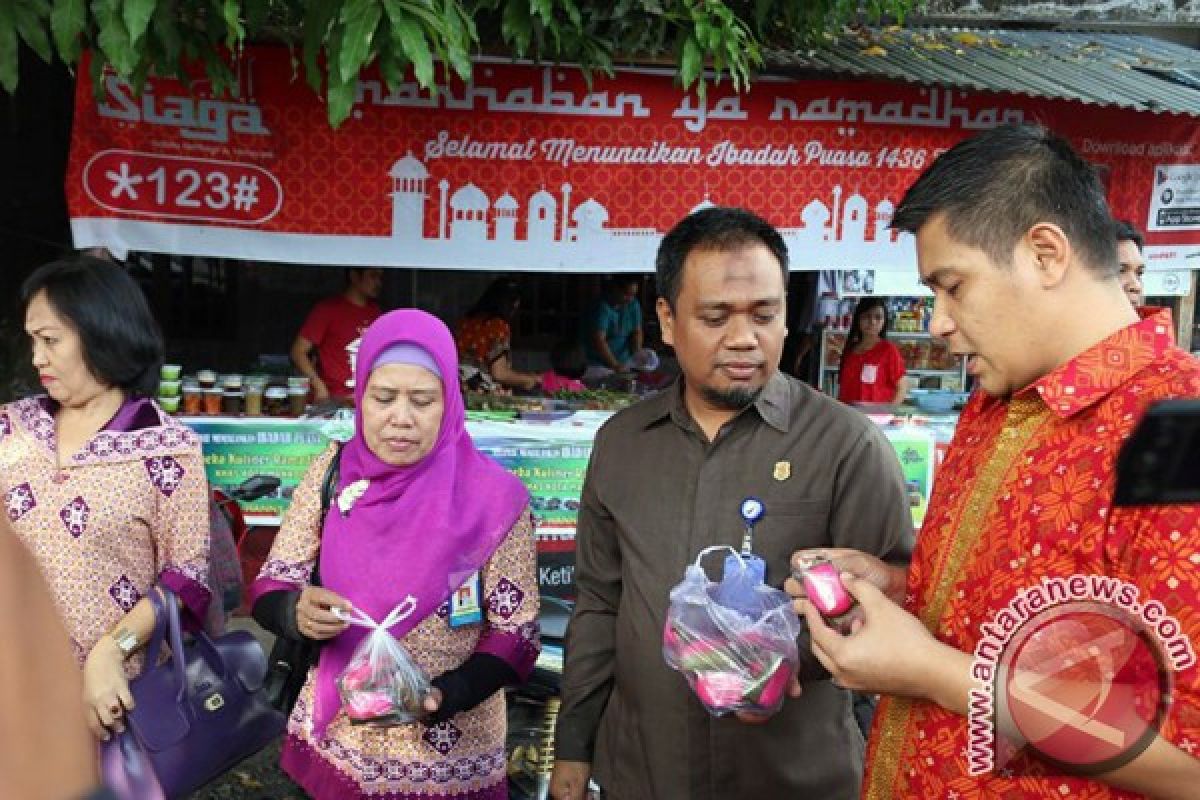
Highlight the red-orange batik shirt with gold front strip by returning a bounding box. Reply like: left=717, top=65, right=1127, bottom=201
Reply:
left=863, top=309, right=1200, bottom=800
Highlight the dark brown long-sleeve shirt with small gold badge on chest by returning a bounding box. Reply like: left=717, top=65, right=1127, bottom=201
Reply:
left=556, top=374, right=912, bottom=800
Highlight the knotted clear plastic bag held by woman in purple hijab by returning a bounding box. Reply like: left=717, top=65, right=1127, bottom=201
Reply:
left=337, top=597, right=430, bottom=727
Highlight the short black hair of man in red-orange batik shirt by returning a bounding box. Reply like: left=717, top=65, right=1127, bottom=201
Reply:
left=892, top=125, right=1120, bottom=276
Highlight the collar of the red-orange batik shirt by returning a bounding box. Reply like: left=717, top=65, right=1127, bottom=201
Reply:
left=984, top=308, right=1175, bottom=419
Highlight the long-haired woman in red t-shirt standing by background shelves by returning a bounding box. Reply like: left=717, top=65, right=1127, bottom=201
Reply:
left=838, top=297, right=906, bottom=403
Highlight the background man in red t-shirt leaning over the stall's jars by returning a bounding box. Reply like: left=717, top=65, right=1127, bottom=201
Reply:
left=292, top=269, right=383, bottom=403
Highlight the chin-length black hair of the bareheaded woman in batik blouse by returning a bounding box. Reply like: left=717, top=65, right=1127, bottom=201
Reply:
left=20, top=255, right=163, bottom=397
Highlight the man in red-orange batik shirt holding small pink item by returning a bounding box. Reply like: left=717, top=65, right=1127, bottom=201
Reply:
left=787, top=126, right=1200, bottom=800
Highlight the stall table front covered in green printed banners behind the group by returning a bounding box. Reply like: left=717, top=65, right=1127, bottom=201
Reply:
left=181, top=411, right=954, bottom=597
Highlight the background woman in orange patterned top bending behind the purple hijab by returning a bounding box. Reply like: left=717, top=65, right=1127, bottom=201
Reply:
left=456, top=277, right=540, bottom=391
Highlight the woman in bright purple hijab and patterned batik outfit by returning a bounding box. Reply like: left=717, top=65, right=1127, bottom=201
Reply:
left=251, top=309, right=539, bottom=800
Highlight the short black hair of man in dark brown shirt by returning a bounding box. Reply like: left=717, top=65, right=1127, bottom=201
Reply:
left=654, top=205, right=787, bottom=309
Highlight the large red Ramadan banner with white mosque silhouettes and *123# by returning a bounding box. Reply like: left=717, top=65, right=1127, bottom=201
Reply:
left=66, top=47, right=1200, bottom=277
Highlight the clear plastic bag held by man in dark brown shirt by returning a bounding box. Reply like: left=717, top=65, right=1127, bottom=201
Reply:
left=662, top=547, right=800, bottom=716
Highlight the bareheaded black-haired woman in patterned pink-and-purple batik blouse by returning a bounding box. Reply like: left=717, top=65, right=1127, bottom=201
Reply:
left=0, top=258, right=210, bottom=739
